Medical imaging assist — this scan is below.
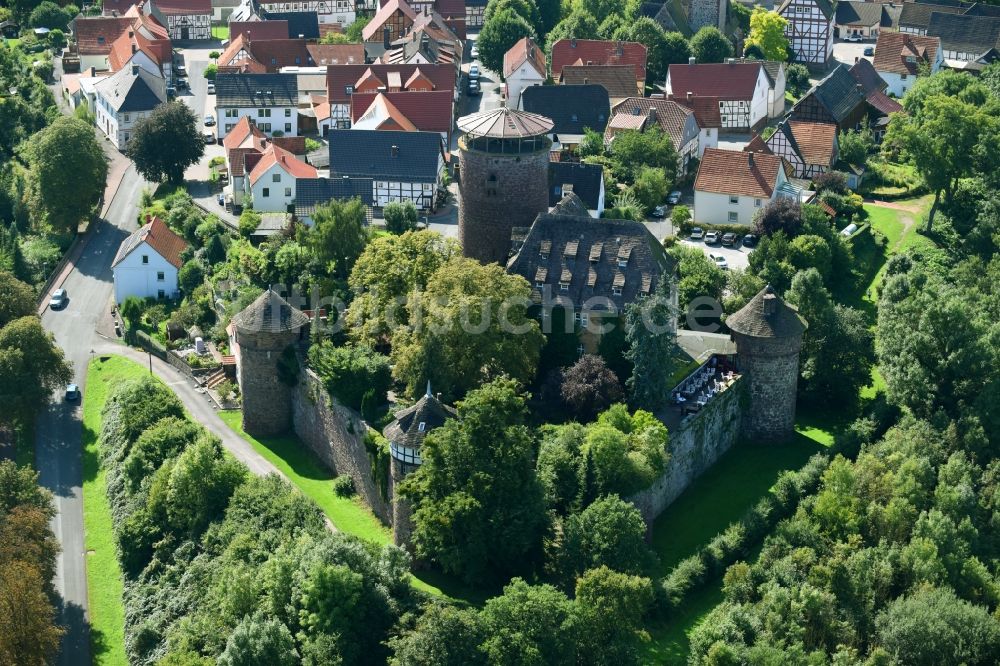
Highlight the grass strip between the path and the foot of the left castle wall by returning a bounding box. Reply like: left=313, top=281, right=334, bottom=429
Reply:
left=219, top=411, right=498, bottom=605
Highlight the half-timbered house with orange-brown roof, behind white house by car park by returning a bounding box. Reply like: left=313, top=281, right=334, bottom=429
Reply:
left=744, top=119, right=837, bottom=179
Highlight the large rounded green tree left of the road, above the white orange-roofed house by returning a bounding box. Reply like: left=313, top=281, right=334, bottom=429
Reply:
left=27, top=118, right=108, bottom=231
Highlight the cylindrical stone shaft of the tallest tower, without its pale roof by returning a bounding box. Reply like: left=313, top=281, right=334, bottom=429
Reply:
left=458, top=140, right=549, bottom=263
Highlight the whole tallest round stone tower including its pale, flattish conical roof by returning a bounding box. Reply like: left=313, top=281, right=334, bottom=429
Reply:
left=458, top=107, right=553, bottom=264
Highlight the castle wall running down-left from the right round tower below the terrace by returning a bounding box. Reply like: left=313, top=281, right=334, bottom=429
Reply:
left=629, top=377, right=747, bottom=527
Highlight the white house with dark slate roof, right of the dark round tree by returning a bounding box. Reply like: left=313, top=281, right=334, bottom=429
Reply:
left=215, top=74, right=299, bottom=139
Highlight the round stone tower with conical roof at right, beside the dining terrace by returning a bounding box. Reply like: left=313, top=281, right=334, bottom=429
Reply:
left=726, top=285, right=808, bottom=441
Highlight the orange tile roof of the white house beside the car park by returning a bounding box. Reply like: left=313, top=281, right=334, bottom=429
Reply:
left=694, top=148, right=784, bottom=199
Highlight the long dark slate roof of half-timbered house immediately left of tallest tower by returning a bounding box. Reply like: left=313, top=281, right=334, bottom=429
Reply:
left=327, top=129, right=441, bottom=183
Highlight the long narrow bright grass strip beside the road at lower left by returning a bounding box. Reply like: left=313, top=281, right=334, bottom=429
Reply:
left=83, top=356, right=147, bottom=665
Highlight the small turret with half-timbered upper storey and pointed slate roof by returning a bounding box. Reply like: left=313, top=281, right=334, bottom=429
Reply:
left=382, top=382, right=455, bottom=547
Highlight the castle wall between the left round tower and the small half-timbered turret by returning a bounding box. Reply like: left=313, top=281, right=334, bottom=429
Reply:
left=292, top=369, right=392, bottom=524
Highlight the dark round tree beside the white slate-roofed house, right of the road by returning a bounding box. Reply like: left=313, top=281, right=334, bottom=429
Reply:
left=125, top=101, right=205, bottom=184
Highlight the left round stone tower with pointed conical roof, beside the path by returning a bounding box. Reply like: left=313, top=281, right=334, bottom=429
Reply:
left=232, top=289, right=309, bottom=437
